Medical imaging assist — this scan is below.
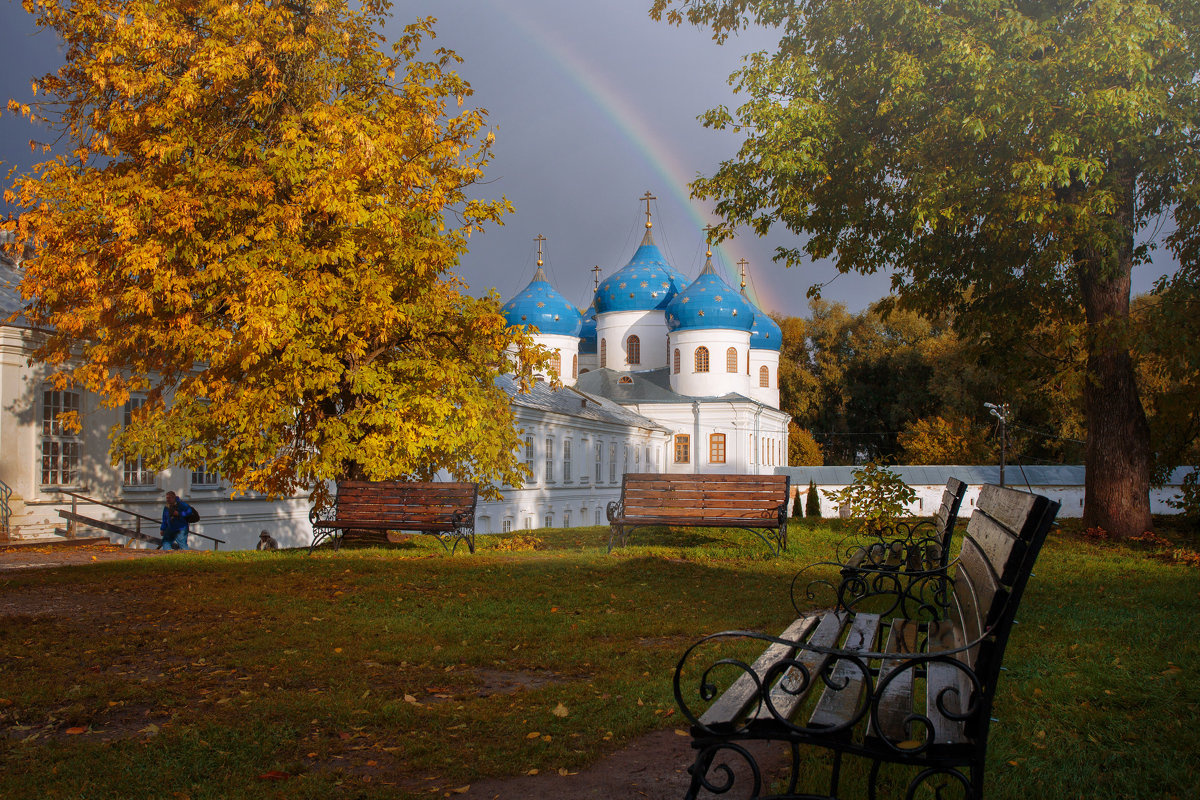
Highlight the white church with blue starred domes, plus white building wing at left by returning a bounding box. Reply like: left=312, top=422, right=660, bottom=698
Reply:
left=0, top=203, right=788, bottom=549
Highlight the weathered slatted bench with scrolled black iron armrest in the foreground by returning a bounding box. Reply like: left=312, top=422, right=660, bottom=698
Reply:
left=674, top=486, right=1058, bottom=799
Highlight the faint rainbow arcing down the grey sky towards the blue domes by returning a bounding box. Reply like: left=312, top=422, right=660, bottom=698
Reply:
left=491, top=2, right=770, bottom=311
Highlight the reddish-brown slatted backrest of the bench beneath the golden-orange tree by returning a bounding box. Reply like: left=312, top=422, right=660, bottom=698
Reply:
left=337, top=481, right=479, bottom=530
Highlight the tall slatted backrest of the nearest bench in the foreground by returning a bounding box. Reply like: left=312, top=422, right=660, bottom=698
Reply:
left=949, top=485, right=1060, bottom=734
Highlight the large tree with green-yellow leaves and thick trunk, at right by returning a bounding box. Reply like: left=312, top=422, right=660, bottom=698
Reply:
left=652, top=0, right=1200, bottom=536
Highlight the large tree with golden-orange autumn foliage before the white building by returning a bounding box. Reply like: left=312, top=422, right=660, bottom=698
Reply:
left=7, top=0, right=536, bottom=501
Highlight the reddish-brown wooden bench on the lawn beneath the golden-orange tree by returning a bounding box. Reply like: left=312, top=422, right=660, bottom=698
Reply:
left=308, top=481, right=479, bottom=553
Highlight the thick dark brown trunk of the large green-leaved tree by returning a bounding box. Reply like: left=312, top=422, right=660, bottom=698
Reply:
left=1080, top=171, right=1153, bottom=539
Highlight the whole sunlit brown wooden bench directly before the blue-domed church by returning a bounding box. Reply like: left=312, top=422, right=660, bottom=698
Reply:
left=608, top=473, right=791, bottom=553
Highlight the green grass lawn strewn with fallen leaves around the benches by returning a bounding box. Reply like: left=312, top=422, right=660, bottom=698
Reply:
left=0, top=521, right=1200, bottom=800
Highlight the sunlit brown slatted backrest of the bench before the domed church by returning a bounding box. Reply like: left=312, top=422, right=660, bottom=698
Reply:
left=620, top=473, right=791, bottom=519
